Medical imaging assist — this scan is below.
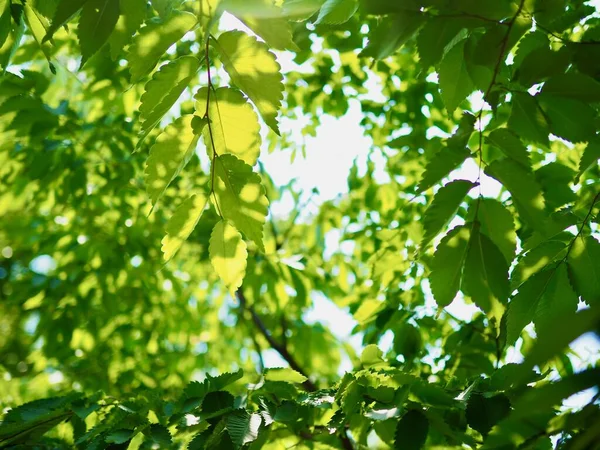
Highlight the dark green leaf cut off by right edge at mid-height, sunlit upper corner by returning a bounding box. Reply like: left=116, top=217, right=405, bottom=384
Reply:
left=567, top=236, right=600, bottom=305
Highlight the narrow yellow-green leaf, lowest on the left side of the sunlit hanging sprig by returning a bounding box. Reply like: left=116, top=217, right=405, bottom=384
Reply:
left=161, top=194, right=208, bottom=262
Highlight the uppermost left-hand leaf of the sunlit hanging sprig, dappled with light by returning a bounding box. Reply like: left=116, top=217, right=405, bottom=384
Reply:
left=127, top=11, right=197, bottom=83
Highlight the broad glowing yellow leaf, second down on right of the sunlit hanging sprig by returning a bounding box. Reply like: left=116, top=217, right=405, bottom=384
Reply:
left=194, top=88, right=261, bottom=166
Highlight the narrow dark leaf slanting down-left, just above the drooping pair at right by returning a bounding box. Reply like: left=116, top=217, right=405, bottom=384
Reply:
left=421, top=180, right=477, bottom=249
